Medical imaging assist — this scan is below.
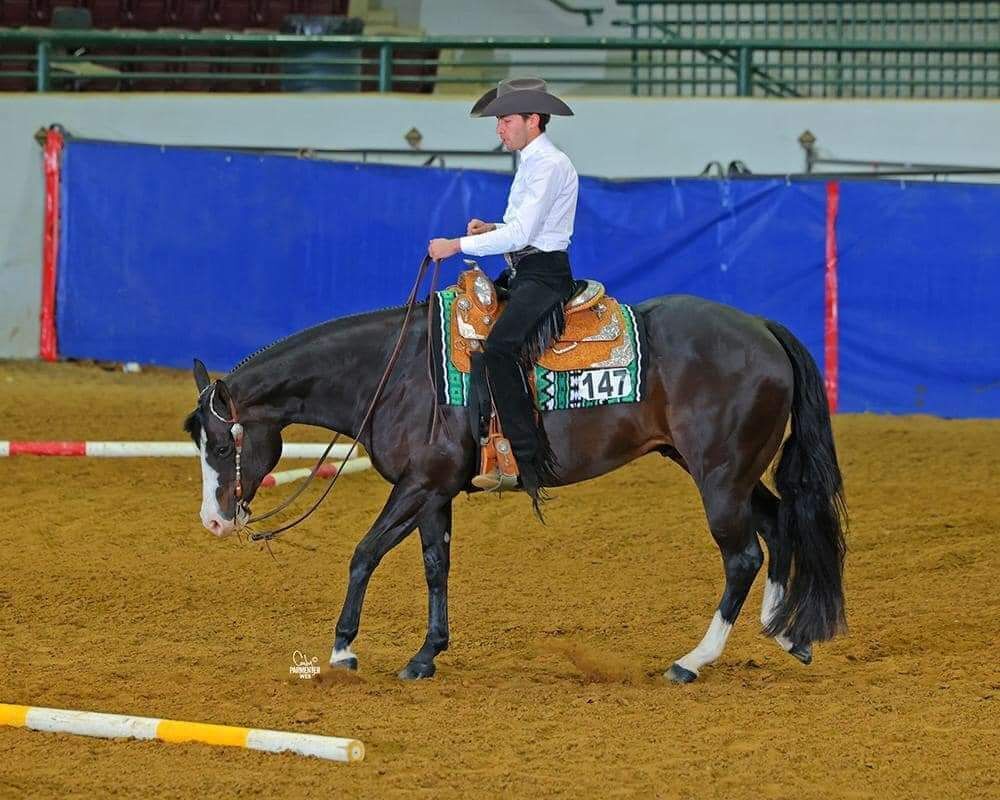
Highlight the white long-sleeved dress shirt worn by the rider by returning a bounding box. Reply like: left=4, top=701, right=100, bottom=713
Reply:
left=459, top=133, right=579, bottom=256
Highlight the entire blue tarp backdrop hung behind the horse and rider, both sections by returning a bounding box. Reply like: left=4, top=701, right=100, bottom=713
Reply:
left=57, top=141, right=1000, bottom=416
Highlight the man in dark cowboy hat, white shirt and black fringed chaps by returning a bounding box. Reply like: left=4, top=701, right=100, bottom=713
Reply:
left=427, top=78, right=579, bottom=503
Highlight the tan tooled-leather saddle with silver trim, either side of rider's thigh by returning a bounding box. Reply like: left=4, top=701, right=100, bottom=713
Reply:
left=448, top=267, right=635, bottom=373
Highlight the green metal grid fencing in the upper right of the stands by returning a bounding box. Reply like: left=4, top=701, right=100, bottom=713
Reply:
left=612, top=0, right=1000, bottom=98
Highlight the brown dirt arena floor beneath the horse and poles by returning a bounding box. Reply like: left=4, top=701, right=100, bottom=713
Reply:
left=0, top=362, right=1000, bottom=800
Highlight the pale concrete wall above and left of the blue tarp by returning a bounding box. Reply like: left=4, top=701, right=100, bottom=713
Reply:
left=0, top=91, right=1000, bottom=357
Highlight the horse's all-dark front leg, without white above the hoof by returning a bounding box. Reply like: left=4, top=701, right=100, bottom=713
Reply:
left=399, top=500, right=451, bottom=680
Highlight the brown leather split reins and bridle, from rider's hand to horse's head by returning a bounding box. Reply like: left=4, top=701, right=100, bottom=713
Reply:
left=208, top=256, right=441, bottom=542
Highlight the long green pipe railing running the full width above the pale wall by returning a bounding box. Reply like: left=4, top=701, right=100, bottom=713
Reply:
left=0, top=29, right=1000, bottom=97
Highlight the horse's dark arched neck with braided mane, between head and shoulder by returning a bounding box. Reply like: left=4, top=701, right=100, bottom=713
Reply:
left=231, top=316, right=402, bottom=436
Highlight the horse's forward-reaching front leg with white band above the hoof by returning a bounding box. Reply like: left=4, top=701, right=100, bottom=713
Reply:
left=330, top=481, right=434, bottom=669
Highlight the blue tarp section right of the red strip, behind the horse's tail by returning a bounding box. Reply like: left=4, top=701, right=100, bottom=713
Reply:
left=837, top=182, right=1000, bottom=417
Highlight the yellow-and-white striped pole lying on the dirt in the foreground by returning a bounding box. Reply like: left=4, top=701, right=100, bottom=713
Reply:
left=0, top=703, right=365, bottom=763
